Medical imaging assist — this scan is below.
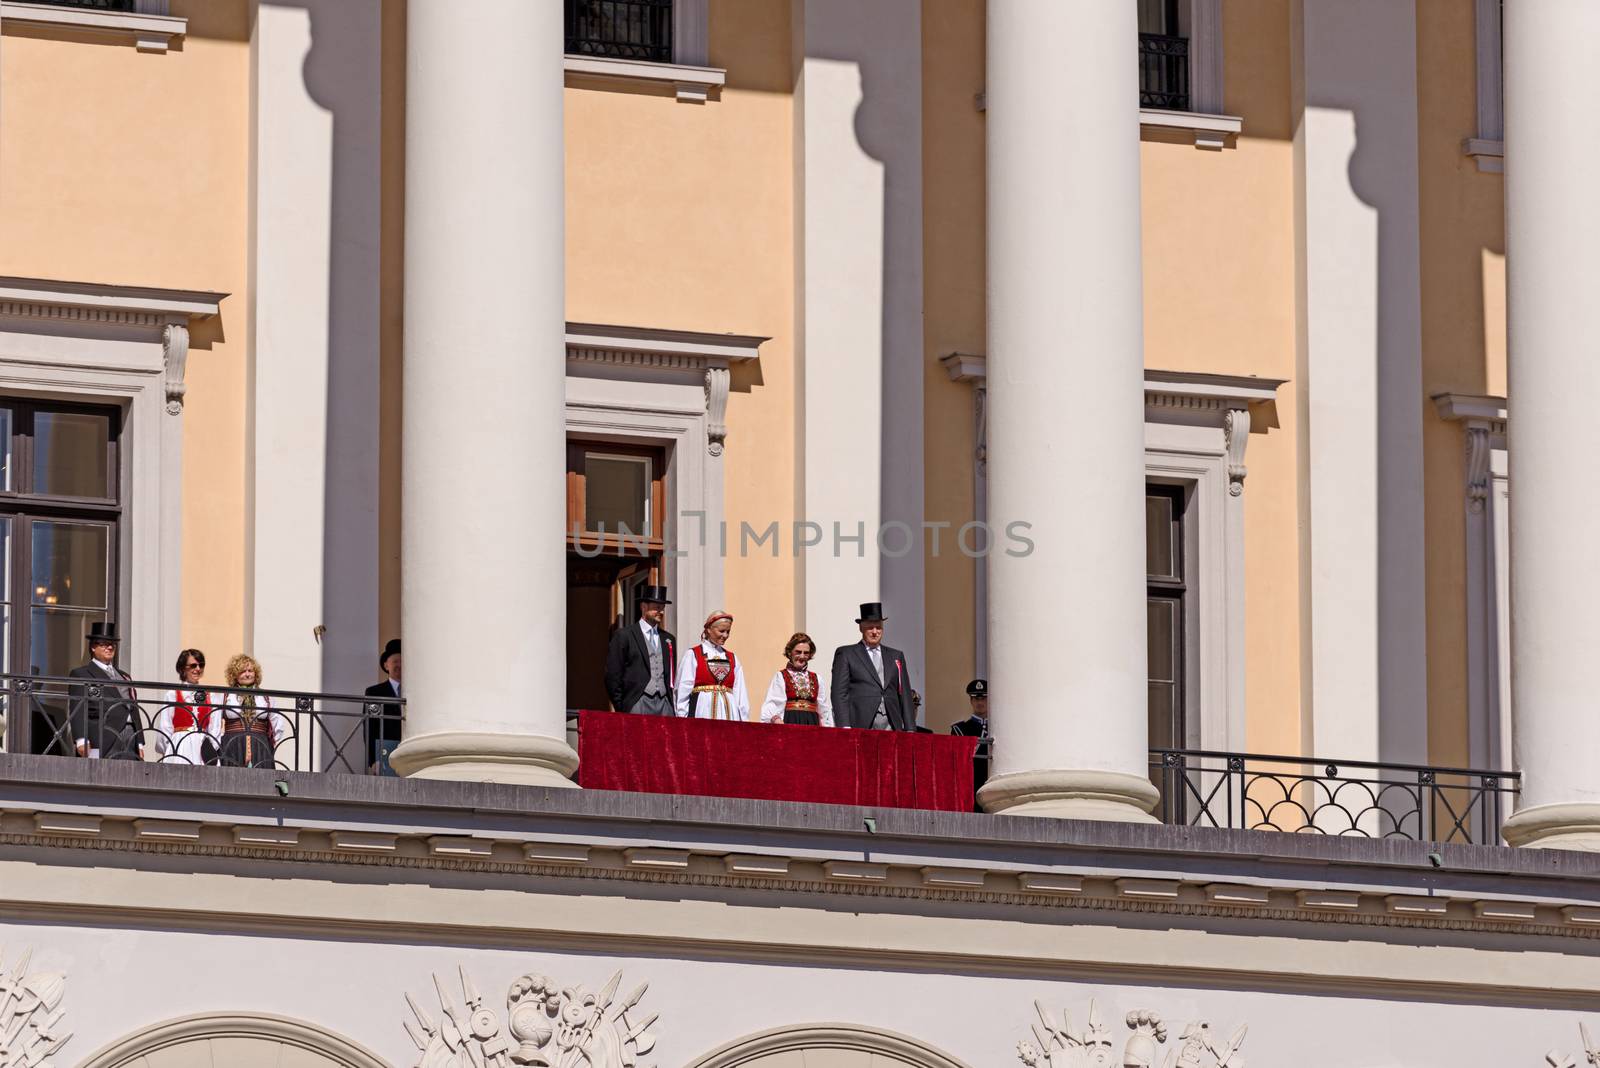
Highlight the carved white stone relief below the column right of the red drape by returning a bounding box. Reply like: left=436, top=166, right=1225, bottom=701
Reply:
left=1016, top=1001, right=1248, bottom=1068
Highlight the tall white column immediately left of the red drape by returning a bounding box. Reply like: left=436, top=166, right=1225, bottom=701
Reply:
left=392, top=0, right=578, bottom=787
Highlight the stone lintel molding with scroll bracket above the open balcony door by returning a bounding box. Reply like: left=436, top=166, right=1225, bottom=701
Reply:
left=566, top=323, right=770, bottom=456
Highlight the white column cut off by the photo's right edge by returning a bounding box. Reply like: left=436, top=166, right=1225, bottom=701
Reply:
left=1506, top=0, right=1600, bottom=849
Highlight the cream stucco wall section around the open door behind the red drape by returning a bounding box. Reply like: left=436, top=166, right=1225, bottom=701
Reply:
left=566, top=0, right=797, bottom=674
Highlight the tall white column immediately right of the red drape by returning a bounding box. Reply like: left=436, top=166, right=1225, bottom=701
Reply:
left=979, top=0, right=1157, bottom=820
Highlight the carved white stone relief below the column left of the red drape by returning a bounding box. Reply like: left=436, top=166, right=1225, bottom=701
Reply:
left=412, top=967, right=659, bottom=1068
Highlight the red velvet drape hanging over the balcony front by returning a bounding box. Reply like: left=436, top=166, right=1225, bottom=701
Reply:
left=578, top=711, right=978, bottom=812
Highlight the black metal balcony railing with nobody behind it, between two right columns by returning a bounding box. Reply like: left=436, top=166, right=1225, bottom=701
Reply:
left=1150, top=750, right=1522, bottom=846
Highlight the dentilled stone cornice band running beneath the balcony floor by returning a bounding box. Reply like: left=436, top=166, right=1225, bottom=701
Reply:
left=0, top=811, right=1600, bottom=938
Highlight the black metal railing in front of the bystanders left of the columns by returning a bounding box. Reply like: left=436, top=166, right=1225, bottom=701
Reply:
left=0, top=675, right=405, bottom=775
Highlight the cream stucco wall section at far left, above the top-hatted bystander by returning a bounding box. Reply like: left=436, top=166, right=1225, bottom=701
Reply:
left=0, top=0, right=250, bottom=674
